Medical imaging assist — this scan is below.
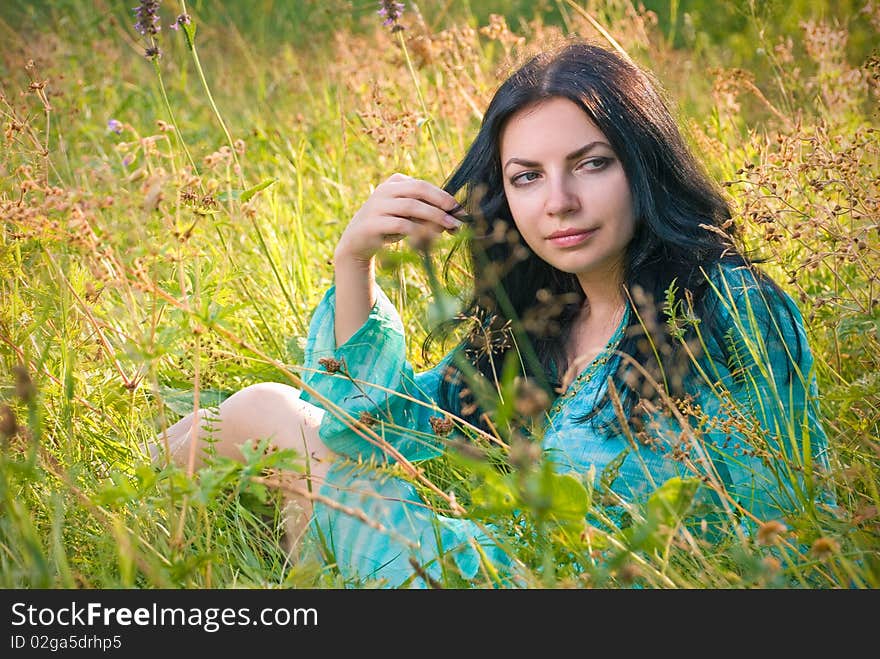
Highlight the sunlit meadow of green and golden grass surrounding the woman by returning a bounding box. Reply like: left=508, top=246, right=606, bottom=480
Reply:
left=0, top=0, right=880, bottom=589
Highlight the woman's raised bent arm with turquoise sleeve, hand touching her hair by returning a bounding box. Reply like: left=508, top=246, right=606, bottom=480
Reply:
left=303, top=174, right=468, bottom=460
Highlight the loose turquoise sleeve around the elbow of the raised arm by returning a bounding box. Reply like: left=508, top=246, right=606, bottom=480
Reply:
left=301, top=286, right=451, bottom=462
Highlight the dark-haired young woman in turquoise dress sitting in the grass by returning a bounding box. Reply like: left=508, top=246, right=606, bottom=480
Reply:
left=156, top=42, right=826, bottom=586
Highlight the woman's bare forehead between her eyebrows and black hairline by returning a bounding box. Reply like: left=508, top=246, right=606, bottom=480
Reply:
left=499, top=97, right=608, bottom=157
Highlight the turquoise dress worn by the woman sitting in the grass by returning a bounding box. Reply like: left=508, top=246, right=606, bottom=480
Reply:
left=302, top=266, right=827, bottom=587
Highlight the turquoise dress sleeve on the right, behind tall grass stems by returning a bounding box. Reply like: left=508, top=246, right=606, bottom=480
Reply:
left=696, top=267, right=828, bottom=520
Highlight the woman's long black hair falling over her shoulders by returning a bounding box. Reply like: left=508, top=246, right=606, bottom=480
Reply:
left=424, top=41, right=796, bottom=436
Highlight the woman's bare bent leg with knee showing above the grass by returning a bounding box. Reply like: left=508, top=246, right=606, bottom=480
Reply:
left=150, top=382, right=336, bottom=550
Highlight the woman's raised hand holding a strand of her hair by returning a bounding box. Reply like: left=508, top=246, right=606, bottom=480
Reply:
left=334, top=174, right=462, bottom=263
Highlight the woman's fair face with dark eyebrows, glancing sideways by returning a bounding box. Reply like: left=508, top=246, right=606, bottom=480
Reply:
left=500, top=98, right=635, bottom=282
